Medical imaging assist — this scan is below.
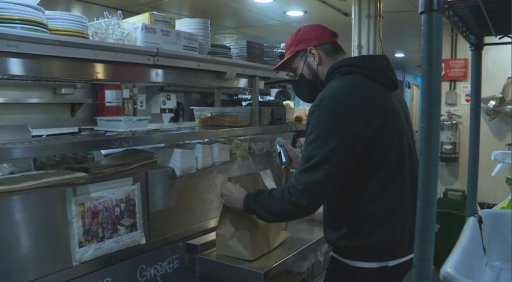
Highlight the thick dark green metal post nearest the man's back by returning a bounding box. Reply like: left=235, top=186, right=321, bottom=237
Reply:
left=412, top=4, right=443, bottom=282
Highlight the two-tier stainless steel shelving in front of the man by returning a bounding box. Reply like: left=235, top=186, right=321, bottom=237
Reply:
left=0, top=27, right=296, bottom=161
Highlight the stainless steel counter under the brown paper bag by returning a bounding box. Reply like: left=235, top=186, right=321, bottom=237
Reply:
left=197, top=220, right=329, bottom=282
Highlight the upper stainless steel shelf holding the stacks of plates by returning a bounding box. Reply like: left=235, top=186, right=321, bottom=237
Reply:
left=0, top=30, right=286, bottom=88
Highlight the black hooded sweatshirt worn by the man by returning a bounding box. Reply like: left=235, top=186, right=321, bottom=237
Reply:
left=244, top=55, right=418, bottom=262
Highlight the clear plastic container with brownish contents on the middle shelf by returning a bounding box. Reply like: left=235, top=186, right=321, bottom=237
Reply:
left=192, top=107, right=251, bottom=128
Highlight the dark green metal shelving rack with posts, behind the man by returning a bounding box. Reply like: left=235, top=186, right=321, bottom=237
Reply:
left=412, top=0, right=512, bottom=281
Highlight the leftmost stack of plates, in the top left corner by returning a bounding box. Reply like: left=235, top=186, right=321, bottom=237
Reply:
left=0, top=0, right=48, bottom=33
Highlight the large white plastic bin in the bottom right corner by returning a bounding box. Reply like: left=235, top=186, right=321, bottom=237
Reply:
left=440, top=209, right=512, bottom=282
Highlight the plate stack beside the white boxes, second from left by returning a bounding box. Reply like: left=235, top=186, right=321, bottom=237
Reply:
left=46, top=11, right=89, bottom=38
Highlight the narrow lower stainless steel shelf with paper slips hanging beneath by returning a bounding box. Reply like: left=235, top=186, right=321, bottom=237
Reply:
left=0, top=125, right=287, bottom=162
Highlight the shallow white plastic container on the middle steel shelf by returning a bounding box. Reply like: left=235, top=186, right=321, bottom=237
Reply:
left=95, top=116, right=150, bottom=131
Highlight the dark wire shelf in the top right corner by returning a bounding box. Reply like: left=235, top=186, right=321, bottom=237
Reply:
left=443, top=0, right=512, bottom=46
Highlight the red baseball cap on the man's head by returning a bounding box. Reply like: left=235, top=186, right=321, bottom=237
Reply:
left=274, top=24, right=338, bottom=71
